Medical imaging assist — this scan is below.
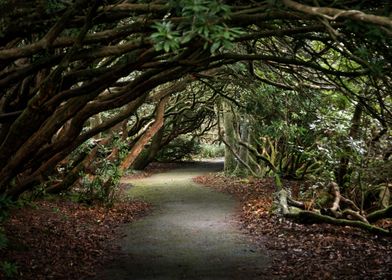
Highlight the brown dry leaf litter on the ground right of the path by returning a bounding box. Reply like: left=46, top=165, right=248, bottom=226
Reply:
left=195, top=175, right=392, bottom=279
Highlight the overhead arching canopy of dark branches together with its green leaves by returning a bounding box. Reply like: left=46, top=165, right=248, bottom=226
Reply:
left=0, top=0, right=392, bottom=201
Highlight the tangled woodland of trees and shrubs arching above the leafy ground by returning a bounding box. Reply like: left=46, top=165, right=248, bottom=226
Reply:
left=0, top=0, right=392, bottom=274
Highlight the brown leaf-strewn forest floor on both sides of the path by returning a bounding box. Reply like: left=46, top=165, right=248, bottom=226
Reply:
left=0, top=161, right=392, bottom=280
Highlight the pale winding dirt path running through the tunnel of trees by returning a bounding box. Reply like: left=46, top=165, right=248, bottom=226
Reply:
left=96, top=163, right=268, bottom=280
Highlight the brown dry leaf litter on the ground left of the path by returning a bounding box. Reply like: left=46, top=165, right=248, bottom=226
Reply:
left=0, top=201, right=149, bottom=280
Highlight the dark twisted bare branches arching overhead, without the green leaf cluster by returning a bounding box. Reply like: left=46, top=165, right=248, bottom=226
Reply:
left=0, top=0, right=390, bottom=199
